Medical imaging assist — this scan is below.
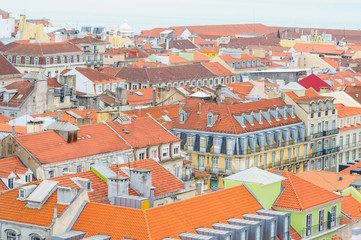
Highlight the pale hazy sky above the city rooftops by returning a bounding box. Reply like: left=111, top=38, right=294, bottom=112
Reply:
left=1, top=0, right=361, bottom=32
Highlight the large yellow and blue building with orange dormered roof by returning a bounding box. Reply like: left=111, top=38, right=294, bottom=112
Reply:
left=171, top=98, right=310, bottom=186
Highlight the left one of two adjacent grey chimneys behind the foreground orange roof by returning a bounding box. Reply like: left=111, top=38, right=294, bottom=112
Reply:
left=107, top=176, right=129, bottom=204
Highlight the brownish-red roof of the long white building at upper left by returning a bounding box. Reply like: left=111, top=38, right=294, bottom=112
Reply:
left=0, top=40, right=83, bottom=56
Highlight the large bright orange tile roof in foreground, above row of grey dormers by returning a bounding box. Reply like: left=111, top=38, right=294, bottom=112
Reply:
left=73, top=186, right=262, bottom=240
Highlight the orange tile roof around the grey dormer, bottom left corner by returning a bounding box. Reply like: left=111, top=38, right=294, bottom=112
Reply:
left=0, top=188, right=68, bottom=227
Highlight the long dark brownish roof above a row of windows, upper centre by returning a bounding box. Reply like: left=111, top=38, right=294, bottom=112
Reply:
left=115, top=64, right=217, bottom=84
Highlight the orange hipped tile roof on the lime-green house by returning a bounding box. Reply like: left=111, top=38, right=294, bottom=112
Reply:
left=268, top=170, right=343, bottom=211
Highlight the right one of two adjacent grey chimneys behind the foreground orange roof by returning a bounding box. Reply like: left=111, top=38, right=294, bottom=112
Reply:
left=129, top=168, right=152, bottom=198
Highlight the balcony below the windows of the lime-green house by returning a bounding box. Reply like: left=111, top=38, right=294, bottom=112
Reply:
left=291, top=217, right=342, bottom=239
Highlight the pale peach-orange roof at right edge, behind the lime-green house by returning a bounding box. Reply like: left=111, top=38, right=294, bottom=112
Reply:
left=296, top=170, right=361, bottom=192
